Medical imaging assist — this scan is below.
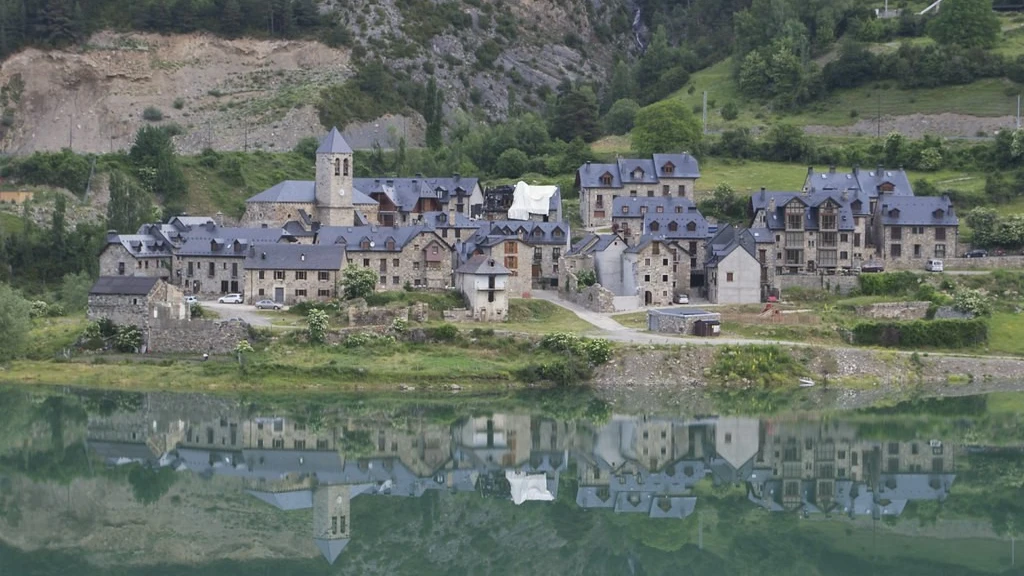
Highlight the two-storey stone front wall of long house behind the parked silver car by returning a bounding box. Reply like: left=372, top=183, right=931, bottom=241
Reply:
left=243, top=264, right=341, bottom=305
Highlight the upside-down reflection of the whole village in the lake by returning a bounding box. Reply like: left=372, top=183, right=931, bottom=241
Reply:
left=88, top=401, right=954, bottom=563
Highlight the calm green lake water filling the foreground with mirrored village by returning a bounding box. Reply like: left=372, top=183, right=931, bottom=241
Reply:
left=0, top=388, right=1024, bottom=576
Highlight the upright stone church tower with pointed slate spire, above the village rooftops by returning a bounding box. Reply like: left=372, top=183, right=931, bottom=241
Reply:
left=316, top=128, right=355, bottom=227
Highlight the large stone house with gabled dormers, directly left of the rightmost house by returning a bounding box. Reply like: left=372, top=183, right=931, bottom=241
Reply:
left=751, top=190, right=873, bottom=274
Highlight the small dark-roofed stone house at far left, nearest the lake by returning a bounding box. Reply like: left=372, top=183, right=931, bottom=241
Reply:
left=86, top=276, right=189, bottom=334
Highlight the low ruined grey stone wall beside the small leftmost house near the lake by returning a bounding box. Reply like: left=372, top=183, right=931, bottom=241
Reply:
left=146, top=320, right=249, bottom=355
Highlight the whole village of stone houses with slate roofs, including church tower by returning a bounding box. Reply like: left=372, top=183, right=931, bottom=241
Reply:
left=89, top=129, right=958, bottom=338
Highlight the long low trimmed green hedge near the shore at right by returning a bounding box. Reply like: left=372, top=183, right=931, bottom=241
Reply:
left=853, top=319, right=988, bottom=348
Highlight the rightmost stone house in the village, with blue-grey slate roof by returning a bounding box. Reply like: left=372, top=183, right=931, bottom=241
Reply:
left=873, top=195, right=959, bottom=259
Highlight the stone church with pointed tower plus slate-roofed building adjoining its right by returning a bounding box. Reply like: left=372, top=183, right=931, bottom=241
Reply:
left=242, top=128, right=483, bottom=228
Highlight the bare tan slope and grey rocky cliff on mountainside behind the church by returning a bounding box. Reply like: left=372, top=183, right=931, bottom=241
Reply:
left=0, top=0, right=634, bottom=154
